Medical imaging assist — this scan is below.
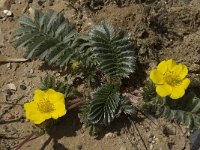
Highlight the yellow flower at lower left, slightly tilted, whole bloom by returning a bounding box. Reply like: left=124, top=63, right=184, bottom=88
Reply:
left=24, top=89, right=67, bottom=124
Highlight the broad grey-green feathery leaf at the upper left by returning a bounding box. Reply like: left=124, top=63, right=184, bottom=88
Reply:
left=13, top=10, right=76, bottom=68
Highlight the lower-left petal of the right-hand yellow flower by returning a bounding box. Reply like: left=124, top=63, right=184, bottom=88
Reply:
left=156, top=84, right=172, bottom=97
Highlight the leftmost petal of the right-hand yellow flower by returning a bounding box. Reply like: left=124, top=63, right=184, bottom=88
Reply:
left=150, top=70, right=164, bottom=84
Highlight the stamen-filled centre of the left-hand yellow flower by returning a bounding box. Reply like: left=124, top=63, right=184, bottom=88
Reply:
left=37, top=99, right=55, bottom=113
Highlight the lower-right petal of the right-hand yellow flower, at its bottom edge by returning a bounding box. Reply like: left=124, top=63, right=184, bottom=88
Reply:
left=170, top=85, right=185, bottom=99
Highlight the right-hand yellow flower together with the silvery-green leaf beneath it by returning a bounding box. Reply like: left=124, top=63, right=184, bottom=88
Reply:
left=143, top=59, right=200, bottom=129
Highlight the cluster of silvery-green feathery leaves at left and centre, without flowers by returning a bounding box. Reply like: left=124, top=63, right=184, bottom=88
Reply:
left=13, top=10, right=138, bottom=134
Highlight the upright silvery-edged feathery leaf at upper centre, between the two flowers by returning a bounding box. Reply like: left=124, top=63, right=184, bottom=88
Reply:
left=89, top=21, right=135, bottom=78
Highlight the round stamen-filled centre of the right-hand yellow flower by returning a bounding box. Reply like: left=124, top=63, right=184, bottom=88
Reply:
left=164, top=71, right=181, bottom=86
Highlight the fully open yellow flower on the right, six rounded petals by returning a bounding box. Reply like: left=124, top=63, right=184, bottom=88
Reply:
left=150, top=59, right=190, bottom=99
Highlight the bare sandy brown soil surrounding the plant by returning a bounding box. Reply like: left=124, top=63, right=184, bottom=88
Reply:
left=0, top=0, right=200, bottom=150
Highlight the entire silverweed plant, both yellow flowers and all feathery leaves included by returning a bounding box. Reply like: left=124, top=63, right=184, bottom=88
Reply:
left=12, top=10, right=200, bottom=148
